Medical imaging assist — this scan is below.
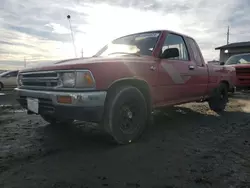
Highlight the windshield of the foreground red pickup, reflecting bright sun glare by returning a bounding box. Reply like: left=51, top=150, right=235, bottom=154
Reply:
left=95, top=32, right=160, bottom=56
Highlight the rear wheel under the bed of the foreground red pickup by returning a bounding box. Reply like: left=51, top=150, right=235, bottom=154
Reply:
left=208, top=83, right=228, bottom=112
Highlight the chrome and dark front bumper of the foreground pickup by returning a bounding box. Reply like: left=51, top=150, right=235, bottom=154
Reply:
left=15, top=88, right=107, bottom=122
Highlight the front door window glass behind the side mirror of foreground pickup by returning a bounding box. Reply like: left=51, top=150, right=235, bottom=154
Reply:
left=162, top=34, right=189, bottom=61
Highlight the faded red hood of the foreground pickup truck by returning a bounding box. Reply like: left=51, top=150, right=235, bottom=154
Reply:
left=21, top=55, right=155, bottom=72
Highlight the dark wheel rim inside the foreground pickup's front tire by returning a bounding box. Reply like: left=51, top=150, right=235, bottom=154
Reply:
left=119, top=102, right=139, bottom=134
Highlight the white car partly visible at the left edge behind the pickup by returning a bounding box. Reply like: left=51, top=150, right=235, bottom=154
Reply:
left=0, top=70, right=19, bottom=91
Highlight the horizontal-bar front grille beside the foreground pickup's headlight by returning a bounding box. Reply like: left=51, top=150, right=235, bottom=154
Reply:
left=22, top=71, right=59, bottom=88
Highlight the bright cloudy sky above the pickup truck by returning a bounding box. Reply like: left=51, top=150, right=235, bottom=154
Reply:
left=0, top=0, right=250, bottom=69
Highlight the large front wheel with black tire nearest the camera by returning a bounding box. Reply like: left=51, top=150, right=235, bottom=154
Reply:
left=104, top=86, right=148, bottom=144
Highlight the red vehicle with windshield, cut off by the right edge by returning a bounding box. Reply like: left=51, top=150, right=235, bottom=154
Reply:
left=221, top=53, right=250, bottom=89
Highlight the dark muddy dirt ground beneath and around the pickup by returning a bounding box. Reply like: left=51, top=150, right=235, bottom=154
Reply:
left=0, top=93, right=250, bottom=188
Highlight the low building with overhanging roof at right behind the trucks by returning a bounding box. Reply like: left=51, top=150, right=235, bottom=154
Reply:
left=215, top=41, right=250, bottom=62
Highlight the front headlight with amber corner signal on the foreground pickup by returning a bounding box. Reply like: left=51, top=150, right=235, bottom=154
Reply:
left=60, top=70, right=95, bottom=88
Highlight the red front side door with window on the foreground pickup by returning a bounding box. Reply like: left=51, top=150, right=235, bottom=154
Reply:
left=159, top=33, right=195, bottom=105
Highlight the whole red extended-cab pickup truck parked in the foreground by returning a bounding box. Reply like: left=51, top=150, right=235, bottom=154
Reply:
left=16, top=30, right=235, bottom=144
